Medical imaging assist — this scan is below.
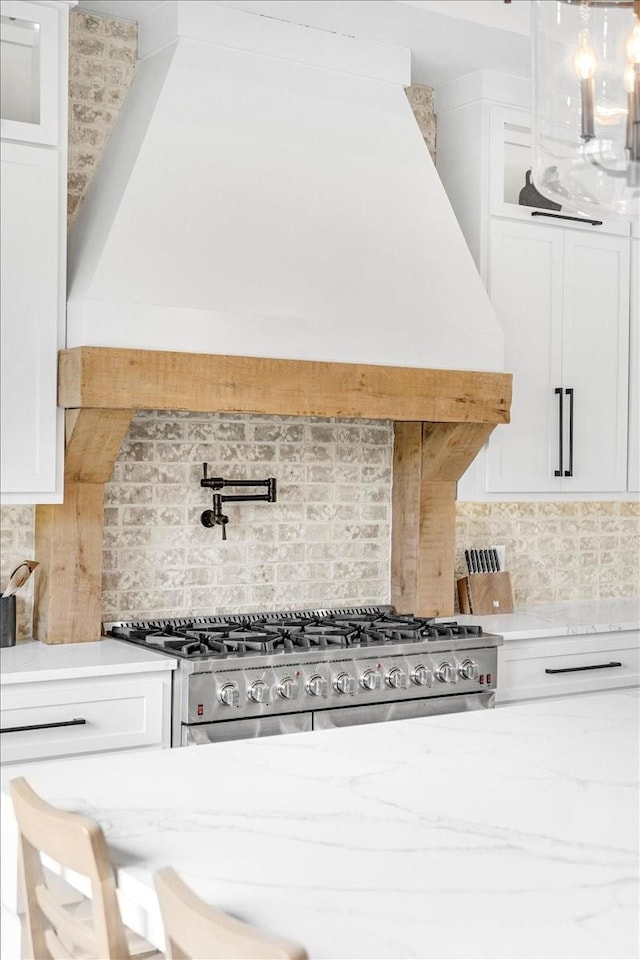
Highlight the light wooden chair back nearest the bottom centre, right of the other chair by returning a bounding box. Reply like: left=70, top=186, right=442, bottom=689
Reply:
left=154, top=867, right=307, bottom=960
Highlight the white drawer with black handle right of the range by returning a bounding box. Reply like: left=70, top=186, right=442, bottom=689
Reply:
left=496, top=630, right=640, bottom=703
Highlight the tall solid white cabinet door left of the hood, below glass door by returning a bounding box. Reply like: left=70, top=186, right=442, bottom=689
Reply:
left=0, top=143, right=60, bottom=502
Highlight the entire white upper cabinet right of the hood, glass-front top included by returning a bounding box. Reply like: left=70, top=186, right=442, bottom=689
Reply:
left=436, top=71, right=639, bottom=500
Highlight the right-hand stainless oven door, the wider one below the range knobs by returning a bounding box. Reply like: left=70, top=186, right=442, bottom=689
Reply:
left=313, top=690, right=496, bottom=730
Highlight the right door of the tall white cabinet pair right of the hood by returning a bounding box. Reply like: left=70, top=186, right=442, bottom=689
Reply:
left=562, top=230, right=630, bottom=493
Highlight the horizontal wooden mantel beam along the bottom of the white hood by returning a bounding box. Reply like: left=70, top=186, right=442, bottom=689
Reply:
left=58, top=347, right=511, bottom=423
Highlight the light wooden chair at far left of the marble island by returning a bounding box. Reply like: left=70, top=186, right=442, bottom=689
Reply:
left=9, top=777, right=162, bottom=960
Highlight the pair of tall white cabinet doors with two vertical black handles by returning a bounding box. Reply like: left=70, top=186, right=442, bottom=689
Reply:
left=486, top=218, right=629, bottom=493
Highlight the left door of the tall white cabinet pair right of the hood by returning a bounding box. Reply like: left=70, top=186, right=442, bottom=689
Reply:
left=486, top=220, right=563, bottom=493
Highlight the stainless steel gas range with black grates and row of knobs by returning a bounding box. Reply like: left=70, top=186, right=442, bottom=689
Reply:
left=104, top=606, right=502, bottom=746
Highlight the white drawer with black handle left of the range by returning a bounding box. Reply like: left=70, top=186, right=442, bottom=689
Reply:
left=0, top=673, right=171, bottom=763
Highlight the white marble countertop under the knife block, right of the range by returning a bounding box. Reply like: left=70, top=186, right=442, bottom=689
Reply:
left=455, top=597, right=640, bottom=641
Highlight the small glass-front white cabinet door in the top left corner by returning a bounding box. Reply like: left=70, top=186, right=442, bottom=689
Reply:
left=0, top=0, right=60, bottom=145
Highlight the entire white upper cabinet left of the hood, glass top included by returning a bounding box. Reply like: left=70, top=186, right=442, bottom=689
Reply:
left=0, top=0, right=72, bottom=503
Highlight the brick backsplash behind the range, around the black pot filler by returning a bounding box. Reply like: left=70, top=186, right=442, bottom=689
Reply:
left=103, top=411, right=393, bottom=620
